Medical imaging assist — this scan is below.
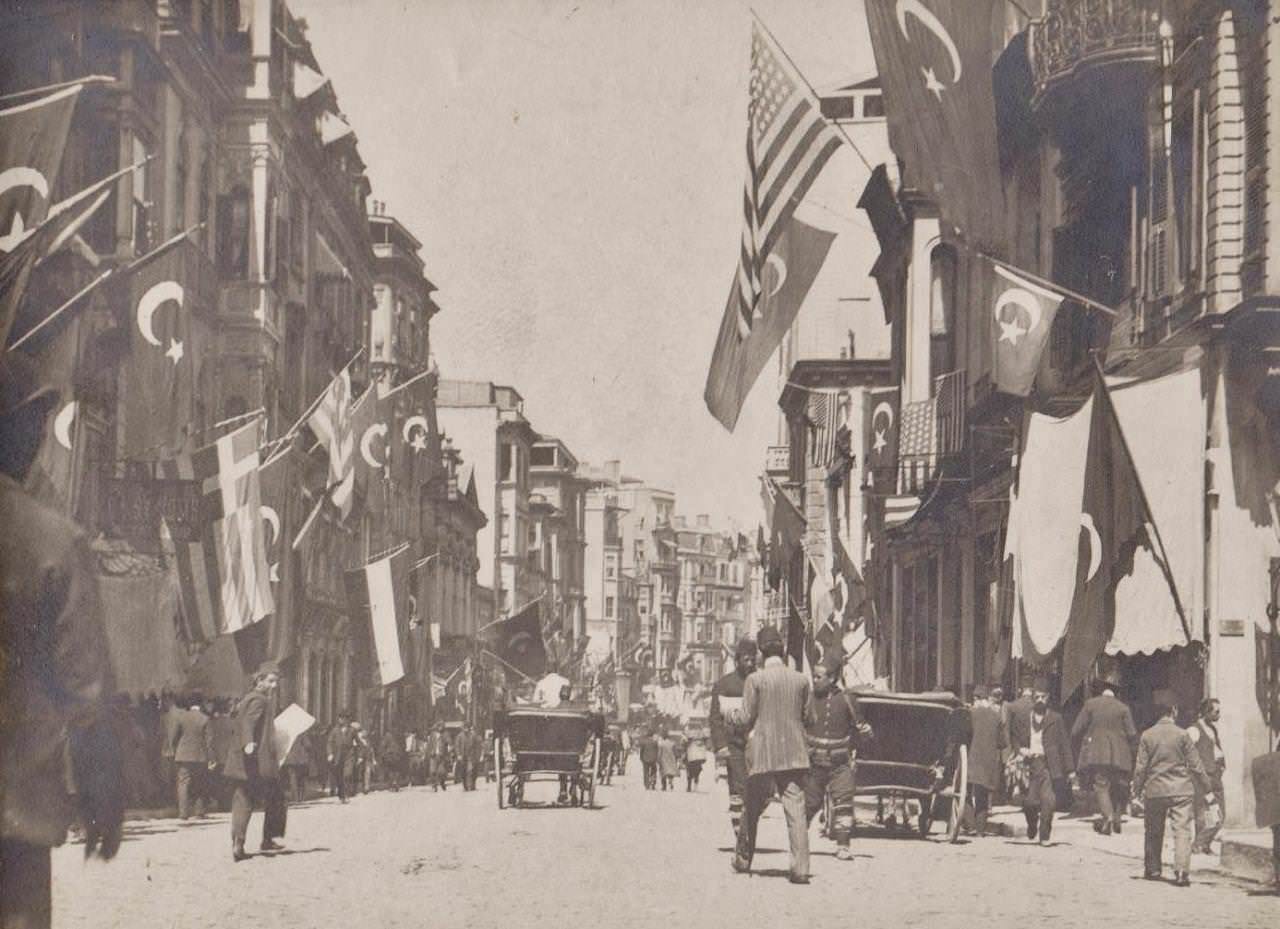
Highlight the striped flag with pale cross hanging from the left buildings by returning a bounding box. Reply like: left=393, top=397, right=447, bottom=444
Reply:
left=160, top=420, right=275, bottom=642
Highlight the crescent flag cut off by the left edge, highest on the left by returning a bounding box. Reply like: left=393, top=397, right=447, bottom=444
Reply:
left=0, top=84, right=81, bottom=255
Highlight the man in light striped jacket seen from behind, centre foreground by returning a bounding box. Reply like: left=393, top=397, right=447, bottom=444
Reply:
left=727, top=626, right=812, bottom=884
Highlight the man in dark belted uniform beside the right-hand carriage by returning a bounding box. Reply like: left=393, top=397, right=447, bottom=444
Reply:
left=804, top=650, right=872, bottom=861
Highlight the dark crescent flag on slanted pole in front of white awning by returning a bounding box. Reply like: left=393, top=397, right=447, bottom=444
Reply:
left=1062, top=371, right=1151, bottom=699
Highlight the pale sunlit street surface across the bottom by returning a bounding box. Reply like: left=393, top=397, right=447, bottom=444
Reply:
left=54, top=764, right=1280, bottom=929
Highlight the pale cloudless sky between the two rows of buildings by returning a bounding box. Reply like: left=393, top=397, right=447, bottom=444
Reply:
left=289, top=0, right=874, bottom=531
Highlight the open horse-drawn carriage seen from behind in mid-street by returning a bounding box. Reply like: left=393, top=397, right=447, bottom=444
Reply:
left=493, top=706, right=604, bottom=809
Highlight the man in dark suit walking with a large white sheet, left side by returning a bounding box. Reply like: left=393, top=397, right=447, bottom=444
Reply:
left=224, top=662, right=288, bottom=861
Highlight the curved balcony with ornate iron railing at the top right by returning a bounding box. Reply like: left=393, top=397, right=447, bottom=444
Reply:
left=1028, top=0, right=1161, bottom=105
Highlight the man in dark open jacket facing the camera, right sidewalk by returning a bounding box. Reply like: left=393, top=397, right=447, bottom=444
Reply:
left=1009, top=678, right=1075, bottom=845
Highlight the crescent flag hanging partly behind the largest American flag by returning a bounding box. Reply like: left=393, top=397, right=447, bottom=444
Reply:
left=703, top=216, right=836, bottom=431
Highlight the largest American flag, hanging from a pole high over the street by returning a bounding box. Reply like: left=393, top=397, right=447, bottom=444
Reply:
left=736, top=23, right=840, bottom=339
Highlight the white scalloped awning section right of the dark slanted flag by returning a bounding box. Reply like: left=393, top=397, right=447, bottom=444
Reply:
left=1106, top=367, right=1206, bottom=655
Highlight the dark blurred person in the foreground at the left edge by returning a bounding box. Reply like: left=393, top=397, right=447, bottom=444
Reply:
left=0, top=351, right=124, bottom=929
